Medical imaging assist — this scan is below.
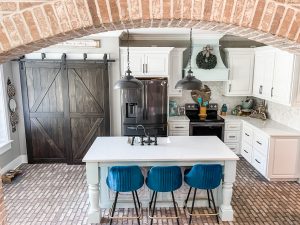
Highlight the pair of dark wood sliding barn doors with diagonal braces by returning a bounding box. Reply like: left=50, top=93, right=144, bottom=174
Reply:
left=20, top=62, right=110, bottom=164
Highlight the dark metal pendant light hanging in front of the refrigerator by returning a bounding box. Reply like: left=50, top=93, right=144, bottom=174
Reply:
left=114, top=30, right=143, bottom=89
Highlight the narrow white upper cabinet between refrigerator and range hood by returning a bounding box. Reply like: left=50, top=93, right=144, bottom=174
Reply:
left=169, top=48, right=185, bottom=97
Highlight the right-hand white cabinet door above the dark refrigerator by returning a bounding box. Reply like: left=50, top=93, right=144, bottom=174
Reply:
left=145, top=53, right=169, bottom=77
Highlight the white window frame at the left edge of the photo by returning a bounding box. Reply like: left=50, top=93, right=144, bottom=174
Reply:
left=0, top=64, right=12, bottom=155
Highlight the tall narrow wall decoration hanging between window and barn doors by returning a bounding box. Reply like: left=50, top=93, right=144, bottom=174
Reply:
left=7, top=79, right=19, bottom=132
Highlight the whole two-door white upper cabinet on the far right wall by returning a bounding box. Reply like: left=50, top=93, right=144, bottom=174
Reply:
left=253, top=47, right=300, bottom=106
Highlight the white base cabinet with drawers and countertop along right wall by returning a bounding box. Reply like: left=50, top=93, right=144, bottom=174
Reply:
left=223, top=115, right=300, bottom=182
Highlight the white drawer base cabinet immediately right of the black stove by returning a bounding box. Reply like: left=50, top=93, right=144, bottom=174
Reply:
left=224, top=119, right=241, bottom=154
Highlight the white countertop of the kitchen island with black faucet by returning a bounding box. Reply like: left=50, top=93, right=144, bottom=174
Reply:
left=83, top=136, right=239, bottom=163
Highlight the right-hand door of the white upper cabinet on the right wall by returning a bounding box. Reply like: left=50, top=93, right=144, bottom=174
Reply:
left=271, top=50, right=294, bottom=105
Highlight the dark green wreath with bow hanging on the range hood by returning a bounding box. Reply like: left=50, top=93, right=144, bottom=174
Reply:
left=196, top=45, right=217, bottom=70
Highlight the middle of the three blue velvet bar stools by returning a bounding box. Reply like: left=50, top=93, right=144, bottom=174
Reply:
left=146, top=166, right=182, bottom=225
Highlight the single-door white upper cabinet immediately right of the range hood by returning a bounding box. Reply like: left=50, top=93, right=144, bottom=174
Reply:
left=224, top=48, right=254, bottom=96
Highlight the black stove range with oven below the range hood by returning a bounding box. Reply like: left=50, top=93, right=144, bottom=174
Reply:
left=185, top=103, right=225, bottom=141
